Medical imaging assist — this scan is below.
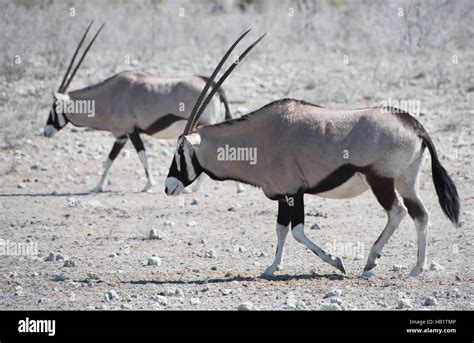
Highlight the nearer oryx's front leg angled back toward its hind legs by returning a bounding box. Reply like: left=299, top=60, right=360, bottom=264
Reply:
left=287, top=193, right=346, bottom=274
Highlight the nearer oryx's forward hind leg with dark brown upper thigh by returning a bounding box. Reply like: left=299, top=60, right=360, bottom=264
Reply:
left=364, top=174, right=407, bottom=272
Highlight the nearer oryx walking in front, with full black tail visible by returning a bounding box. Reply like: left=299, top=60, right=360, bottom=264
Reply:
left=165, top=28, right=460, bottom=276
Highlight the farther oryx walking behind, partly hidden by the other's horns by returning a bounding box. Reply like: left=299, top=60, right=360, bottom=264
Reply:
left=44, top=22, right=234, bottom=192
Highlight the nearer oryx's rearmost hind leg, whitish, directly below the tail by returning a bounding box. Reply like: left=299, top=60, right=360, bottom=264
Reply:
left=395, top=153, right=429, bottom=276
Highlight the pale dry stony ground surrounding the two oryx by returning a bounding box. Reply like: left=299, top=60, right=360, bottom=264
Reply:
left=0, top=1, right=474, bottom=310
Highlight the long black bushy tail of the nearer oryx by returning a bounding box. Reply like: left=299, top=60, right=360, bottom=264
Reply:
left=421, top=133, right=460, bottom=224
